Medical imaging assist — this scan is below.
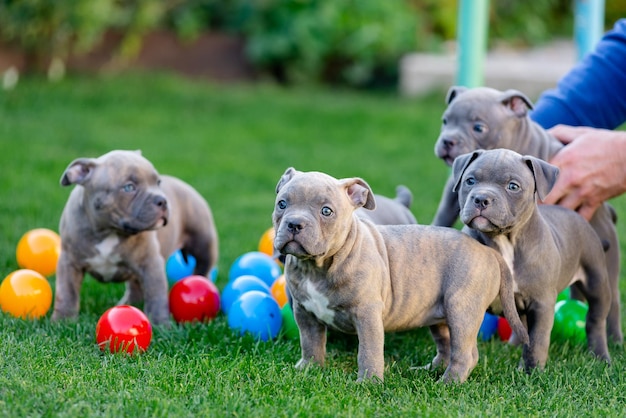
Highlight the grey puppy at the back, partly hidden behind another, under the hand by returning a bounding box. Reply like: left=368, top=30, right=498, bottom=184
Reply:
left=432, top=87, right=624, bottom=343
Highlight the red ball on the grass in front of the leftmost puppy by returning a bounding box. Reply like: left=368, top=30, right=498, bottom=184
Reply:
left=96, top=305, right=152, bottom=354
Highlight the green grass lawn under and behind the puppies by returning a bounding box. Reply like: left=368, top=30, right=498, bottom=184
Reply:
left=0, top=74, right=626, bottom=417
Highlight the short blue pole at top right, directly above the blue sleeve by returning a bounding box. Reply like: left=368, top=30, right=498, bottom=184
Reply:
left=574, top=0, right=604, bottom=61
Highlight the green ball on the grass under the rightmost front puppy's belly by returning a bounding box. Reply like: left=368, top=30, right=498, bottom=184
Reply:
left=551, top=299, right=589, bottom=344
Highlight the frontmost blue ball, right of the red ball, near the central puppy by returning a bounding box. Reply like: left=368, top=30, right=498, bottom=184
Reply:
left=228, top=290, right=283, bottom=341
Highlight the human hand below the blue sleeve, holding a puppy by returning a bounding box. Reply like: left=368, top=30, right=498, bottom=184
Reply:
left=543, top=125, right=626, bottom=220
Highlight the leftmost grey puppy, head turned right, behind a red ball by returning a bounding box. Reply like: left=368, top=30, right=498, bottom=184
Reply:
left=52, top=151, right=218, bottom=325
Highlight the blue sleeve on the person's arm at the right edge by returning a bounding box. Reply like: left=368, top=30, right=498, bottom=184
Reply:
left=531, top=19, right=626, bottom=129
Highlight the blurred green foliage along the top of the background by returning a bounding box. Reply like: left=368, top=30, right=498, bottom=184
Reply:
left=0, top=0, right=624, bottom=87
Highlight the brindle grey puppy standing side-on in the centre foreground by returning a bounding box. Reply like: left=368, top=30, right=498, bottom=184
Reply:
left=272, top=168, right=528, bottom=382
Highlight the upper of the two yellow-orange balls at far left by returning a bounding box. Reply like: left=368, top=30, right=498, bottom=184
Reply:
left=15, top=228, right=61, bottom=277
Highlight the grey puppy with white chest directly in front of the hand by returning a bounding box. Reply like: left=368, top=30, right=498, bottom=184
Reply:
left=453, top=149, right=611, bottom=370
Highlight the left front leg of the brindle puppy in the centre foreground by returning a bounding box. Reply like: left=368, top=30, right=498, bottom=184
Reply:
left=293, top=300, right=326, bottom=370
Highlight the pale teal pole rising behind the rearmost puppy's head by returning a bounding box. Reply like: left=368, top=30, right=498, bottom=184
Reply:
left=456, top=0, right=489, bottom=87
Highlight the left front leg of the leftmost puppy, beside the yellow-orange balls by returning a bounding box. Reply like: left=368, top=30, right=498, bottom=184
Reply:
left=52, top=252, right=85, bottom=321
